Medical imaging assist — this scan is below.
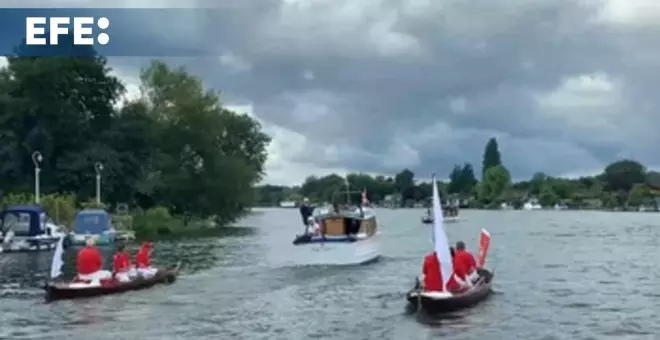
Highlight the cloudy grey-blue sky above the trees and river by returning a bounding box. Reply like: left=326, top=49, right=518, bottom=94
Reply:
left=0, top=0, right=660, bottom=184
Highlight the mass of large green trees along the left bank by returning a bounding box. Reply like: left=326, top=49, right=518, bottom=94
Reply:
left=0, top=53, right=270, bottom=224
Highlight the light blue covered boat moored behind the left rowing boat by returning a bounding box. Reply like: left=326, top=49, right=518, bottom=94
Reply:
left=69, top=209, right=117, bottom=245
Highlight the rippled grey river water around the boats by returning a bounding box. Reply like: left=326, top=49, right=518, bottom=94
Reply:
left=0, top=209, right=660, bottom=340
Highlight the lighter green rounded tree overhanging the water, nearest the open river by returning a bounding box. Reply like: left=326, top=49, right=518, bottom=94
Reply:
left=135, top=62, right=270, bottom=223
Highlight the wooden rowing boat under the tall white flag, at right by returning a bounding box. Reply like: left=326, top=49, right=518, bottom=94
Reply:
left=406, top=269, right=494, bottom=314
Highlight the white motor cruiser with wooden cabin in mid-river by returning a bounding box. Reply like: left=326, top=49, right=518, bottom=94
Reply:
left=290, top=191, right=380, bottom=265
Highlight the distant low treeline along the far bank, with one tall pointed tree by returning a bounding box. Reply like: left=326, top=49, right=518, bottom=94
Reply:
left=257, top=138, right=660, bottom=208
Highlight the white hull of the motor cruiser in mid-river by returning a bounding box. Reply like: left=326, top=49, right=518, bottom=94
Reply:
left=287, top=233, right=380, bottom=265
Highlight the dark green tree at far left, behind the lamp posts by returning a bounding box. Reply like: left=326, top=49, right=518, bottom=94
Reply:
left=0, top=56, right=124, bottom=195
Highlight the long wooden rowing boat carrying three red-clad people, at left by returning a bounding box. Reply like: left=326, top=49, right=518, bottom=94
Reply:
left=44, top=262, right=181, bottom=302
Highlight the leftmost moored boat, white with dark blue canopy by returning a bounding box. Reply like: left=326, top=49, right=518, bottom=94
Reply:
left=0, top=204, right=65, bottom=253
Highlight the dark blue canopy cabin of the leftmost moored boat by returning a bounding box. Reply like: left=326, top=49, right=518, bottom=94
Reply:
left=0, top=204, right=52, bottom=237
